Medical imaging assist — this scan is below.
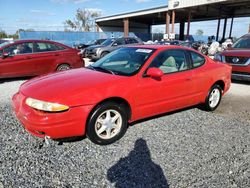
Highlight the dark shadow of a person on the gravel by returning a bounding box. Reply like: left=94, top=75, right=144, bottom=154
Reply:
left=107, top=139, right=169, bottom=188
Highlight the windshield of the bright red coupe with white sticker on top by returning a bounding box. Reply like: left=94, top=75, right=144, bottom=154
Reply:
left=89, top=47, right=155, bottom=76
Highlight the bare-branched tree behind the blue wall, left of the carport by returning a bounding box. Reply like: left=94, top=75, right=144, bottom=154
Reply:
left=64, top=9, right=101, bottom=31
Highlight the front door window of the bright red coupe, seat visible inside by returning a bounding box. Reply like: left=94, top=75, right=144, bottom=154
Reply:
left=150, top=50, right=188, bottom=74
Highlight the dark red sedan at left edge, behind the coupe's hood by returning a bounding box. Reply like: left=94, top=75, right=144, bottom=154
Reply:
left=0, top=40, right=84, bottom=78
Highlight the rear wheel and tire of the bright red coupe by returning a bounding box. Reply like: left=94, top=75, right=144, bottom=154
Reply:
left=204, top=85, right=222, bottom=111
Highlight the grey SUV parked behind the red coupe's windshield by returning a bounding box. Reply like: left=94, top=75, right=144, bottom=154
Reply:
left=85, top=37, right=143, bottom=60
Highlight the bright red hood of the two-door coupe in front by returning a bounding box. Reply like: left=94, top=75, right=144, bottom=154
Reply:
left=20, top=68, right=128, bottom=107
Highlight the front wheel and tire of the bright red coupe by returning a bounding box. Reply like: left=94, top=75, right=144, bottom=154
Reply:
left=86, top=102, right=128, bottom=145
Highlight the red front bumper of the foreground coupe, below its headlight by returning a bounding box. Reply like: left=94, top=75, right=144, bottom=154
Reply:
left=12, top=93, right=93, bottom=139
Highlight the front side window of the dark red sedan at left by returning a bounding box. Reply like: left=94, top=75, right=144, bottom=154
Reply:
left=4, top=42, right=33, bottom=55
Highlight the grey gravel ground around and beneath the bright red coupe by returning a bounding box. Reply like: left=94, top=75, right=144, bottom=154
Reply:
left=0, top=80, right=250, bottom=188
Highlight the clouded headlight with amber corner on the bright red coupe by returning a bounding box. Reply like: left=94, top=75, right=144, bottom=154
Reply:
left=25, top=98, right=69, bottom=112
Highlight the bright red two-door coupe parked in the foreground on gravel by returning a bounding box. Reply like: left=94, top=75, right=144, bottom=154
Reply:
left=13, top=45, right=231, bottom=144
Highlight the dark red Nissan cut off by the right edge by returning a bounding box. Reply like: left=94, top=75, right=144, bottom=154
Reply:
left=214, top=34, right=250, bottom=81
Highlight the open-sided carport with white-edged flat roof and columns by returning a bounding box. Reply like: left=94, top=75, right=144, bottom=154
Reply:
left=96, top=0, right=250, bottom=40
